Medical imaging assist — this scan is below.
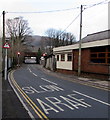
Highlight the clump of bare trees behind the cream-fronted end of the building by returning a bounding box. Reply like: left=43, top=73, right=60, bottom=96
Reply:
left=46, top=28, right=76, bottom=49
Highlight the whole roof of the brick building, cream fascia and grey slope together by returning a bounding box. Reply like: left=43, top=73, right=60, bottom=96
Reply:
left=53, top=30, right=110, bottom=53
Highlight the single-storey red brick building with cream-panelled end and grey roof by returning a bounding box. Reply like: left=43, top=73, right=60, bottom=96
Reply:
left=53, top=30, right=110, bottom=79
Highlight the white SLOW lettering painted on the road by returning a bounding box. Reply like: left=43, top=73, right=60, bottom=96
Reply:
left=22, top=85, right=64, bottom=94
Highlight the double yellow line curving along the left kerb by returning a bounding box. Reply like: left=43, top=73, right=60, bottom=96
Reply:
left=9, top=71, right=49, bottom=120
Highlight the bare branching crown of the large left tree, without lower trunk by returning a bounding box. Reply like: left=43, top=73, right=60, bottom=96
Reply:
left=6, top=17, right=32, bottom=42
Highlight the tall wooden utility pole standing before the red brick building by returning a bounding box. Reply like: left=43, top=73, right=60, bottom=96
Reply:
left=78, top=5, right=83, bottom=76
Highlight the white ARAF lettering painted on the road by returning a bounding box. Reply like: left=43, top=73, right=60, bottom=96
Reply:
left=36, top=94, right=91, bottom=114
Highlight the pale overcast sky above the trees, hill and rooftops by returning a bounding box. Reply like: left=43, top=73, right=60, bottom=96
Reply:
left=0, top=0, right=109, bottom=39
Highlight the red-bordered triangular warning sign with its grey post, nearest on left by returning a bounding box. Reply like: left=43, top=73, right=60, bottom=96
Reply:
left=3, top=42, right=10, bottom=80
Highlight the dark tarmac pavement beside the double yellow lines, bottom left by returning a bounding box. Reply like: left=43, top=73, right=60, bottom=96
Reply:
left=0, top=72, right=31, bottom=120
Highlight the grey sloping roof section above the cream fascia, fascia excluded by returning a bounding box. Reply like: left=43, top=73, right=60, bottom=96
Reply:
left=82, top=30, right=110, bottom=43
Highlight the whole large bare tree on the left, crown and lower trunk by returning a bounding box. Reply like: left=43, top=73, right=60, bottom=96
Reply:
left=6, top=17, right=32, bottom=65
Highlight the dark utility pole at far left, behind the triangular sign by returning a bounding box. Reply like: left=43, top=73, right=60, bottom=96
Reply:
left=2, top=11, right=5, bottom=77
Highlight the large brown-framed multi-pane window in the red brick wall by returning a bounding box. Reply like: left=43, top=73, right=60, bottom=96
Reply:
left=90, top=47, right=110, bottom=64
